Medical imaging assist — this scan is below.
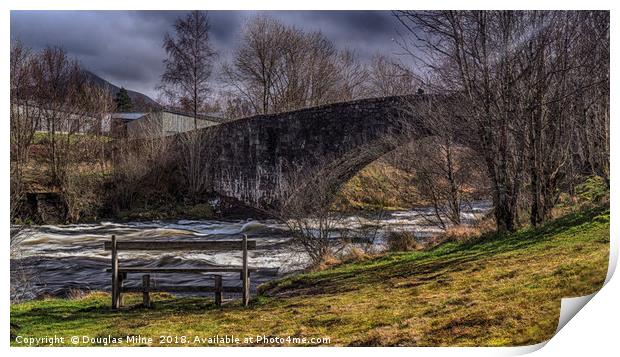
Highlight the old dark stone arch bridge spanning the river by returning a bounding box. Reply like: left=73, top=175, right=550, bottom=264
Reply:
left=189, top=95, right=436, bottom=209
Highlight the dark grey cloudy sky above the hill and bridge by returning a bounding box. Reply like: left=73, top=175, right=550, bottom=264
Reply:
left=11, top=11, right=410, bottom=98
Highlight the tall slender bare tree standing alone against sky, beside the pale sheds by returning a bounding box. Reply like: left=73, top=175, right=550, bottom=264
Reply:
left=160, top=10, right=215, bottom=129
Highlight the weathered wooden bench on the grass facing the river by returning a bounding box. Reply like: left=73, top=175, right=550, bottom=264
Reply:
left=104, top=234, right=257, bottom=309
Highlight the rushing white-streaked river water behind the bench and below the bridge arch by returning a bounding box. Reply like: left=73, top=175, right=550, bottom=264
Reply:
left=11, top=203, right=490, bottom=298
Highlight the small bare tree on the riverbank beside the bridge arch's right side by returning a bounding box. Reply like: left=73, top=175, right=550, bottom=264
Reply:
left=390, top=94, right=488, bottom=229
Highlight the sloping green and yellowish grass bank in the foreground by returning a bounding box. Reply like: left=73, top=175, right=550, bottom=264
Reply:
left=11, top=207, right=609, bottom=346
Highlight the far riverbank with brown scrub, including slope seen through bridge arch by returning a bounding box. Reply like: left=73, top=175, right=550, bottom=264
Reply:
left=12, top=152, right=429, bottom=225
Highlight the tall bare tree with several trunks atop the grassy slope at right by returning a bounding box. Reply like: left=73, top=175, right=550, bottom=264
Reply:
left=396, top=11, right=608, bottom=230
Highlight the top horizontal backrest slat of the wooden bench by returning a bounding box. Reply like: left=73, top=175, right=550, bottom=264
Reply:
left=103, top=240, right=256, bottom=251
